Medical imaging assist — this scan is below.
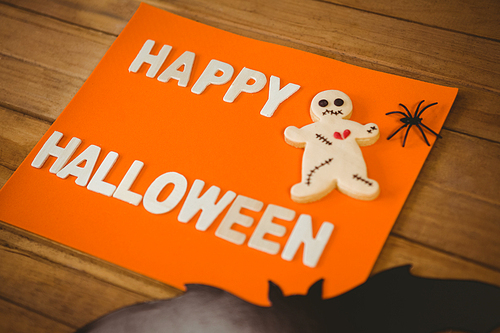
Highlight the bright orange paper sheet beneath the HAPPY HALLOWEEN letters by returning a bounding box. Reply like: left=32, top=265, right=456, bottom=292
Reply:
left=0, top=4, right=457, bottom=305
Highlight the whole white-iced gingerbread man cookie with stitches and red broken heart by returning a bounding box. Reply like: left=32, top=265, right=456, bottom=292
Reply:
left=285, top=90, right=380, bottom=203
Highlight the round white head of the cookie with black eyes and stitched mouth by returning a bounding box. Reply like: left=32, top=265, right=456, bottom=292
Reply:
left=311, top=90, right=352, bottom=121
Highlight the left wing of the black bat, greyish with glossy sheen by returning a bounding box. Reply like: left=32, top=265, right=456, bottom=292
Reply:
left=75, top=284, right=308, bottom=333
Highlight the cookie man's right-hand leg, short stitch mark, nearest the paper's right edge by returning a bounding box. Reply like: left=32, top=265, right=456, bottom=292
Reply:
left=337, top=173, right=380, bottom=200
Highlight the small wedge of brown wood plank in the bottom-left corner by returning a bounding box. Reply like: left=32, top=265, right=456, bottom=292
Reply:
left=0, top=298, right=74, bottom=333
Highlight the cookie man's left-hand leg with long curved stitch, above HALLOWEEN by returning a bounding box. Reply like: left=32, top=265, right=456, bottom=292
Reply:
left=291, top=158, right=336, bottom=203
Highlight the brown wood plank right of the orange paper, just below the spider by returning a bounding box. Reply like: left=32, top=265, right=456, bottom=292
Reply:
left=393, top=132, right=500, bottom=269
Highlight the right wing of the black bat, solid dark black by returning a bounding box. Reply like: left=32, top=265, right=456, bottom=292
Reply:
left=325, top=266, right=500, bottom=333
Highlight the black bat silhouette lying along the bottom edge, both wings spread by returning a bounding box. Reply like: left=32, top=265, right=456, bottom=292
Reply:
left=76, top=266, right=500, bottom=333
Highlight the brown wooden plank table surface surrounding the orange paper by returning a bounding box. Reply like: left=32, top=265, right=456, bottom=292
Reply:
left=0, top=0, right=500, bottom=332
